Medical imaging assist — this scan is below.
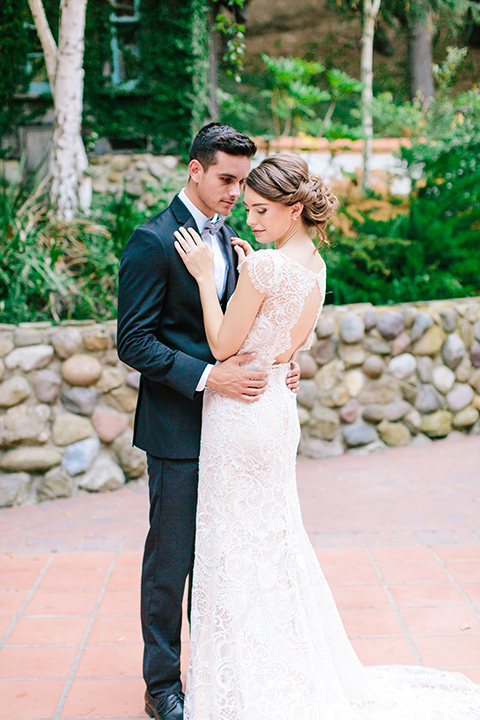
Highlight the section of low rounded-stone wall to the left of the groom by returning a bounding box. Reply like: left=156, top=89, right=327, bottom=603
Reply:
left=0, top=321, right=146, bottom=506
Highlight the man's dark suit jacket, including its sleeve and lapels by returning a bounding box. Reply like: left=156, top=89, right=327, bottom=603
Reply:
left=118, top=196, right=237, bottom=459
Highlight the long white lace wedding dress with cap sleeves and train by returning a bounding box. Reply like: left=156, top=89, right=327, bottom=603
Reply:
left=185, top=250, right=480, bottom=720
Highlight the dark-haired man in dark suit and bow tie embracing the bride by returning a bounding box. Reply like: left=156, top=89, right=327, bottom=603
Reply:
left=118, top=123, right=299, bottom=720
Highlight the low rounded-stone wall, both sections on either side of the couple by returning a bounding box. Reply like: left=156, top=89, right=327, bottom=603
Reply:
left=0, top=298, right=480, bottom=506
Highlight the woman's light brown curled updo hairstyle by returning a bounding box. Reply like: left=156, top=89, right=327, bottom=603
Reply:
left=247, top=153, right=338, bottom=249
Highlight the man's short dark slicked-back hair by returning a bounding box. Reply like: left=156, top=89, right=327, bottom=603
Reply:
left=190, top=123, right=257, bottom=170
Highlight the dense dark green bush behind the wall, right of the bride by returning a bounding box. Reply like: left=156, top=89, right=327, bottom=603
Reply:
left=325, top=140, right=480, bottom=304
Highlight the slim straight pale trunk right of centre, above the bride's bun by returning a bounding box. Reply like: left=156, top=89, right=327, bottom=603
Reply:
left=360, top=0, right=381, bottom=192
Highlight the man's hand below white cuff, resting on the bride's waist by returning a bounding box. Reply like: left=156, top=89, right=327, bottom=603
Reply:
left=207, top=353, right=268, bottom=402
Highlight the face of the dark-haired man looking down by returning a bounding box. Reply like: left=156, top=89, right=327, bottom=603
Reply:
left=190, top=151, right=250, bottom=217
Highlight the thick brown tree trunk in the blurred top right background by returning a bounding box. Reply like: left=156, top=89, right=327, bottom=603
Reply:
left=408, top=0, right=435, bottom=105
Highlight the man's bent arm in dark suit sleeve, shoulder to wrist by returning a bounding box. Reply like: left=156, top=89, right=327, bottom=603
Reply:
left=117, top=228, right=207, bottom=399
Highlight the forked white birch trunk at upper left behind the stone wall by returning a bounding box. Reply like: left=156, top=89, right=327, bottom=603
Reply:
left=29, top=0, right=91, bottom=221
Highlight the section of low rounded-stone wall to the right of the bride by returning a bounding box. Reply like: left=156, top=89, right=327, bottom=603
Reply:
left=298, top=298, right=480, bottom=458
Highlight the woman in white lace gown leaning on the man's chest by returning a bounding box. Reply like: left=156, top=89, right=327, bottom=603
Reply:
left=175, top=155, right=480, bottom=720
